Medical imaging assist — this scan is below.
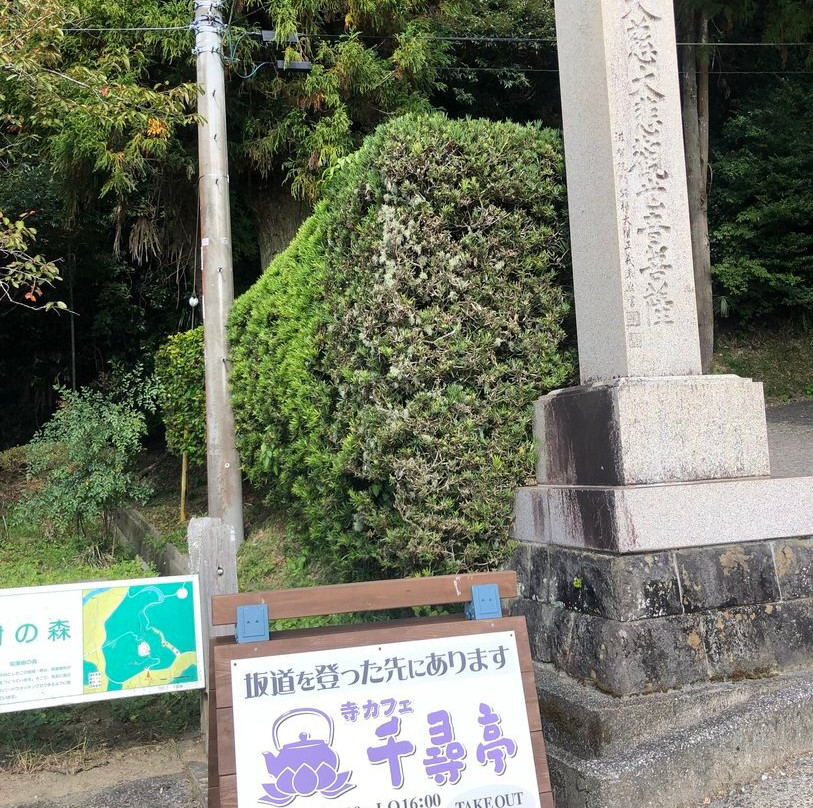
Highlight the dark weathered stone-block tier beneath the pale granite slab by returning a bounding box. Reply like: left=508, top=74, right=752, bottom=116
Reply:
left=512, top=537, right=813, bottom=696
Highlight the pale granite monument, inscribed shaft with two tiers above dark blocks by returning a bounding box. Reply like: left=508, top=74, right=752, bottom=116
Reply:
left=517, top=0, right=813, bottom=553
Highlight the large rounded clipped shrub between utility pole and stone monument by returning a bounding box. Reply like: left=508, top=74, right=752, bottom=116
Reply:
left=225, top=115, right=572, bottom=577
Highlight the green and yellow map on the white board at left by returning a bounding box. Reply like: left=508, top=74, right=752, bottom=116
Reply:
left=82, top=582, right=198, bottom=693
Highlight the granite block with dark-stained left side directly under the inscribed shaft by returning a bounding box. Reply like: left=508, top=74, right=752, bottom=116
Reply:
left=534, top=376, right=770, bottom=486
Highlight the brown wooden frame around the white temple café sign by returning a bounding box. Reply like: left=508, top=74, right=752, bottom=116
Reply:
left=208, top=571, right=554, bottom=808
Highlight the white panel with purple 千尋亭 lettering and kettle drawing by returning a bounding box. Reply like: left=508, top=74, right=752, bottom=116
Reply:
left=231, top=631, right=539, bottom=808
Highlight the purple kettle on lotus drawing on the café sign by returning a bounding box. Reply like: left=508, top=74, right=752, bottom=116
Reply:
left=259, top=707, right=356, bottom=808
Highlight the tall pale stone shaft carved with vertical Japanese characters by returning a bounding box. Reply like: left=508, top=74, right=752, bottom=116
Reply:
left=556, top=0, right=701, bottom=384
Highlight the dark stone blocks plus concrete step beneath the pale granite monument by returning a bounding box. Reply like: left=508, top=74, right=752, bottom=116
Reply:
left=511, top=537, right=813, bottom=808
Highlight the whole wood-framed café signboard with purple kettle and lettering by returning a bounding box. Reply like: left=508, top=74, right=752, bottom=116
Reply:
left=209, top=573, right=553, bottom=808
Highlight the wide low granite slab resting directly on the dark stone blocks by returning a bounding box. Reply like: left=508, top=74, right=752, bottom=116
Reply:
left=514, top=477, right=813, bottom=553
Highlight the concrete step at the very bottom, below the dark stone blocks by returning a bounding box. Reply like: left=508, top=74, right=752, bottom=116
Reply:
left=536, top=665, right=813, bottom=808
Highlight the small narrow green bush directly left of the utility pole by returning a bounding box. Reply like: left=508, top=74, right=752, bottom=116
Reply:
left=155, top=327, right=206, bottom=465
